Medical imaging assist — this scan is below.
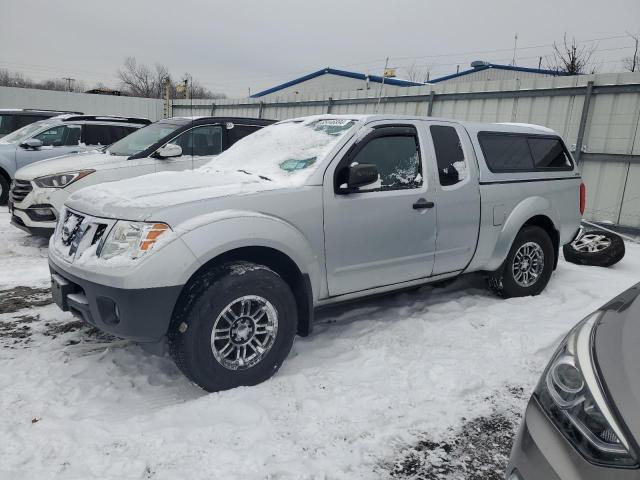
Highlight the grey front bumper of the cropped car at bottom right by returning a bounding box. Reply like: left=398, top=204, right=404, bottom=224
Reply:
left=505, top=397, right=640, bottom=480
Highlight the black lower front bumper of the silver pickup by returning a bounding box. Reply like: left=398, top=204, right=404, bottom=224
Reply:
left=49, top=262, right=182, bottom=342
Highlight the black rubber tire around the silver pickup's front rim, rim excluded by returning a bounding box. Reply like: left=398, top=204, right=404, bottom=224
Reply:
left=168, top=262, right=298, bottom=392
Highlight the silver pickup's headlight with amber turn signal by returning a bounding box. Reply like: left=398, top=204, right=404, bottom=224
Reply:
left=98, top=220, right=171, bottom=260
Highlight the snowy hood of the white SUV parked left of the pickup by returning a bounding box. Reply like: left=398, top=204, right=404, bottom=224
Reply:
left=16, top=150, right=127, bottom=180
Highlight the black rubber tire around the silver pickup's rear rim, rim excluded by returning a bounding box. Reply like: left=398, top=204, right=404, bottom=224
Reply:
left=488, top=225, right=555, bottom=298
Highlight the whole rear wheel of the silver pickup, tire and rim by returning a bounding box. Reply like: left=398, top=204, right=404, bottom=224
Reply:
left=489, top=225, right=554, bottom=298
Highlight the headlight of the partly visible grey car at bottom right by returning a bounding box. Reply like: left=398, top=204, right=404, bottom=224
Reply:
left=534, top=312, right=638, bottom=467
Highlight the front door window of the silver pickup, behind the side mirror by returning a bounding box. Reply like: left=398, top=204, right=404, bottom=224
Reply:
left=350, top=135, right=422, bottom=191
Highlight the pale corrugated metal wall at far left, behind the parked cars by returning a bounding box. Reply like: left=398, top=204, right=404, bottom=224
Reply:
left=0, top=87, right=164, bottom=121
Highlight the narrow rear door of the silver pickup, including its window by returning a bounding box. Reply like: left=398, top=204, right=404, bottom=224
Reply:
left=423, top=121, right=480, bottom=275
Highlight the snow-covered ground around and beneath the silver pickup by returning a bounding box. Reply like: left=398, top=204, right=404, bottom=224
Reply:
left=0, top=207, right=640, bottom=480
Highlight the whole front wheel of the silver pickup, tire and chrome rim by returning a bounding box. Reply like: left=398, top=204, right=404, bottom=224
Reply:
left=169, top=262, right=297, bottom=392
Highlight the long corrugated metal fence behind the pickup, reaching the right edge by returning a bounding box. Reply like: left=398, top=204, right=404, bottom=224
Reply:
left=172, top=73, right=640, bottom=228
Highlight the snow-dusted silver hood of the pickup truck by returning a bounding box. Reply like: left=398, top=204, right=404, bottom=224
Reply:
left=65, top=170, right=289, bottom=220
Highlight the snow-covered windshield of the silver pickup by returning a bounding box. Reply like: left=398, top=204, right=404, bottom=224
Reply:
left=202, top=117, right=356, bottom=182
